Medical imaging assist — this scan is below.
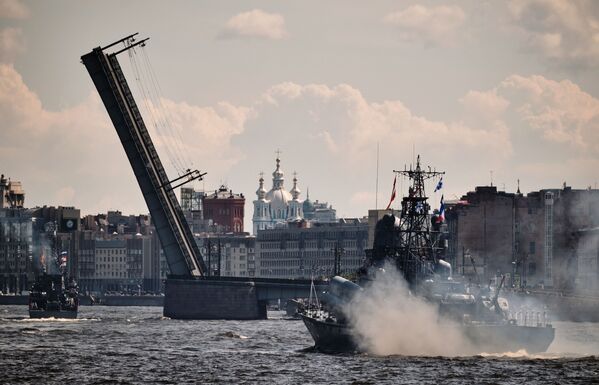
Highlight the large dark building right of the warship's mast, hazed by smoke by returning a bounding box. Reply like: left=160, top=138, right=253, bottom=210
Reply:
left=446, top=186, right=599, bottom=291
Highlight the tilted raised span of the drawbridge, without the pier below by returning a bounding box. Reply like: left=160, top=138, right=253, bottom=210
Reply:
left=81, top=35, right=206, bottom=277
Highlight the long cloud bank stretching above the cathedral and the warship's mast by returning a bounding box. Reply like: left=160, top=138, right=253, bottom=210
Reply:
left=258, top=83, right=510, bottom=162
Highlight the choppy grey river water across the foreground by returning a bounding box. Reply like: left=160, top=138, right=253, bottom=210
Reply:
left=0, top=306, right=599, bottom=384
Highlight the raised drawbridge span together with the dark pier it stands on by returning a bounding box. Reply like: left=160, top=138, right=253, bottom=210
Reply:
left=81, top=34, right=324, bottom=319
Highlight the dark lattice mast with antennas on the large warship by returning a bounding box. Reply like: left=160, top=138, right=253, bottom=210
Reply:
left=393, top=155, right=445, bottom=285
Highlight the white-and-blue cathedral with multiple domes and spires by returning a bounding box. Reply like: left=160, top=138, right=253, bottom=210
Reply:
left=252, top=156, right=304, bottom=234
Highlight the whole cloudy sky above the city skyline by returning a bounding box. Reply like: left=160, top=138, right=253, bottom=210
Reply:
left=0, top=0, right=599, bottom=231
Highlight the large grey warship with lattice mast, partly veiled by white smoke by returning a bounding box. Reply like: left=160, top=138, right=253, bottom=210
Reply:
left=298, top=156, right=555, bottom=354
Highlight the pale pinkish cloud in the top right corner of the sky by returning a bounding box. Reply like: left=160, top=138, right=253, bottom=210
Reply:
left=509, top=0, right=599, bottom=68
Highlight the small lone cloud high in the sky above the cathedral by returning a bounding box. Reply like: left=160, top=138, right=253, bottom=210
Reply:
left=220, top=9, right=287, bottom=40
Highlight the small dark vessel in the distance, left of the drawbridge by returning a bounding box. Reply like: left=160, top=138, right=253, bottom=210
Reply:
left=29, top=273, right=79, bottom=318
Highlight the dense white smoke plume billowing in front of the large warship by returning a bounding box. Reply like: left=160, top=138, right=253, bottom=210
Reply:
left=345, top=269, right=473, bottom=356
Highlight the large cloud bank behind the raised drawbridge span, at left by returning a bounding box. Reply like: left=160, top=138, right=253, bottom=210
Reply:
left=0, top=64, right=250, bottom=213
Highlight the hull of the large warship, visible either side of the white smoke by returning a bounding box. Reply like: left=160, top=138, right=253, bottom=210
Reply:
left=301, top=314, right=555, bottom=354
